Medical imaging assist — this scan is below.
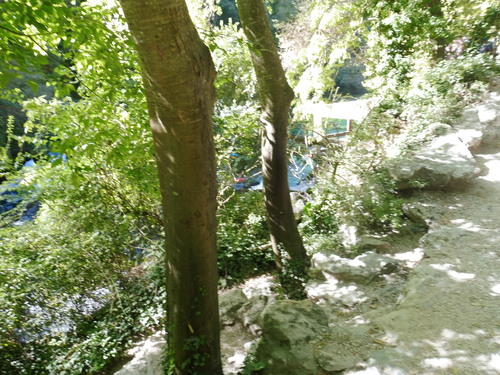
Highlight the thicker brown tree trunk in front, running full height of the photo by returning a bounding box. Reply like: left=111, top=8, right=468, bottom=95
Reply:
left=120, top=0, right=222, bottom=375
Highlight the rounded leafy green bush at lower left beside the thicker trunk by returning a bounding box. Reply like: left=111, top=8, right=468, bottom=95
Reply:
left=0, top=160, right=165, bottom=374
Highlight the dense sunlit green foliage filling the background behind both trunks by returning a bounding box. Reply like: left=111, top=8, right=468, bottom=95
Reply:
left=0, top=0, right=500, bottom=374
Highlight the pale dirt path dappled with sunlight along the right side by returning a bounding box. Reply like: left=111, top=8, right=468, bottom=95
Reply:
left=346, top=141, right=500, bottom=375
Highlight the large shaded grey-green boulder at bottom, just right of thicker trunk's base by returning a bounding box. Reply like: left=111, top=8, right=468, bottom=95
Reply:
left=255, top=300, right=374, bottom=375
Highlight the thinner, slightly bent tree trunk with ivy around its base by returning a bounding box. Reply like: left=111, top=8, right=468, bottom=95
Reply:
left=237, top=0, right=309, bottom=300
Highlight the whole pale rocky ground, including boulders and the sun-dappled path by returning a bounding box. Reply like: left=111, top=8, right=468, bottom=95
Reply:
left=117, top=84, right=500, bottom=375
